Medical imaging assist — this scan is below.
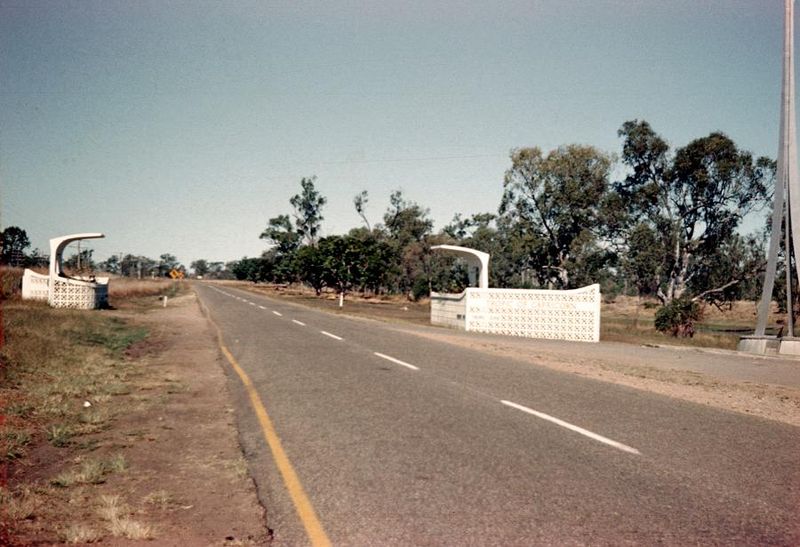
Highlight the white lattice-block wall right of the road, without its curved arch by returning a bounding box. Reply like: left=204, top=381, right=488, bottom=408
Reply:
left=431, top=285, right=600, bottom=342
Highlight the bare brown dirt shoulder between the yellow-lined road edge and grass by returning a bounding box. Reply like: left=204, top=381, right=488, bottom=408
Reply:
left=108, top=293, right=269, bottom=545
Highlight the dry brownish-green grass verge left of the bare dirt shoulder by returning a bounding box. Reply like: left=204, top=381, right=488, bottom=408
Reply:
left=0, top=269, right=180, bottom=545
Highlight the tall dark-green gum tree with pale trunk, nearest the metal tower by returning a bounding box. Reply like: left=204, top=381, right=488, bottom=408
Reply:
left=614, top=120, right=775, bottom=304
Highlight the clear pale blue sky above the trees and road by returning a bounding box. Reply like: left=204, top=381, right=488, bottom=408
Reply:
left=0, top=0, right=783, bottom=266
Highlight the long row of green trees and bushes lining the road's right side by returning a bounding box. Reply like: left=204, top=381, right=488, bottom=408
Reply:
left=198, top=120, right=785, bottom=338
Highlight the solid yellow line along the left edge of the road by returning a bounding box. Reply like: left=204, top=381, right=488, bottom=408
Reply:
left=208, top=308, right=331, bottom=547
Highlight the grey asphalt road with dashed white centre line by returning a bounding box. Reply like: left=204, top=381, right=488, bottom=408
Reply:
left=195, top=284, right=800, bottom=545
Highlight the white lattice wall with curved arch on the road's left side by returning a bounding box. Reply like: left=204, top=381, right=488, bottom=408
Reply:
left=22, top=233, right=108, bottom=310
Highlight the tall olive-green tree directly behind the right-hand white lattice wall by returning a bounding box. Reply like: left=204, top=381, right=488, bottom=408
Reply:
left=500, top=144, right=611, bottom=288
